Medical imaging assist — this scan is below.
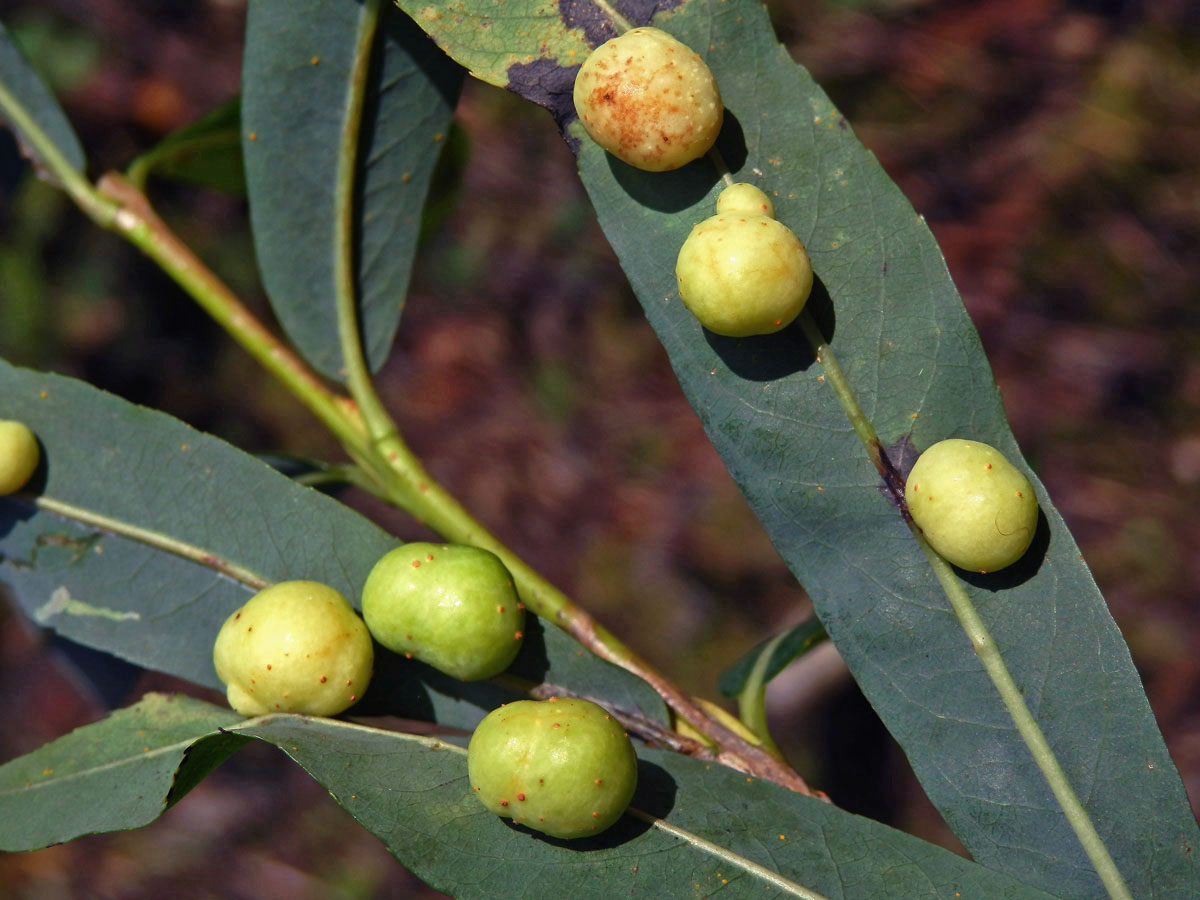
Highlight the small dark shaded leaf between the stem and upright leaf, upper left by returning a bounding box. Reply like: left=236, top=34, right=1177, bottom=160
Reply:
left=128, top=97, right=246, bottom=194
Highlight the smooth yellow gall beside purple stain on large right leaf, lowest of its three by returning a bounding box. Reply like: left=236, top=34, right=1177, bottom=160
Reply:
left=905, top=438, right=1038, bottom=572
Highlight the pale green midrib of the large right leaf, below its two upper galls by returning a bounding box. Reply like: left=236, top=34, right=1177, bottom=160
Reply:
left=800, top=311, right=1133, bottom=900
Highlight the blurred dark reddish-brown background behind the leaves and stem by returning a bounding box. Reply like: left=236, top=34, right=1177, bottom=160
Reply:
left=0, top=0, right=1200, bottom=900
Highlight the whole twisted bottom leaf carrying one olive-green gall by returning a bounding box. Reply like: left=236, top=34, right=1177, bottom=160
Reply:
left=0, top=694, right=1049, bottom=900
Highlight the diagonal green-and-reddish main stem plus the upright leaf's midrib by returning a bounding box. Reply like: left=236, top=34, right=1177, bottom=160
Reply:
left=0, top=65, right=811, bottom=793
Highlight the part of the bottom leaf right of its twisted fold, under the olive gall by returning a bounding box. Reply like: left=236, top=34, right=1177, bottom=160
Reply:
left=236, top=716, right=1051, bottom=900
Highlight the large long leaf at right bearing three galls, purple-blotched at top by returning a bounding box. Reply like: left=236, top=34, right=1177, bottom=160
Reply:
left=400, top=0, right=1200, bottom=900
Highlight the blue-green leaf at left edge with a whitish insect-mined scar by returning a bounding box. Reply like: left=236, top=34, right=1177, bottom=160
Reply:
left=0, top=361, right=665, bottom=728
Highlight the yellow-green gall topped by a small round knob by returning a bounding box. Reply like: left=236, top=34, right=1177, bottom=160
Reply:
left=676, top=184, right=812, bottom=337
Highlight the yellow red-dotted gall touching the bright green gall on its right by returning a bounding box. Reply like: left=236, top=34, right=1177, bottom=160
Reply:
left=212, top=581, right=374, bottom=715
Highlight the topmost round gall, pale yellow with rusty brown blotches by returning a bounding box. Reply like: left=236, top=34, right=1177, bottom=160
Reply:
left=575, top=28, right=725, bottom=172
